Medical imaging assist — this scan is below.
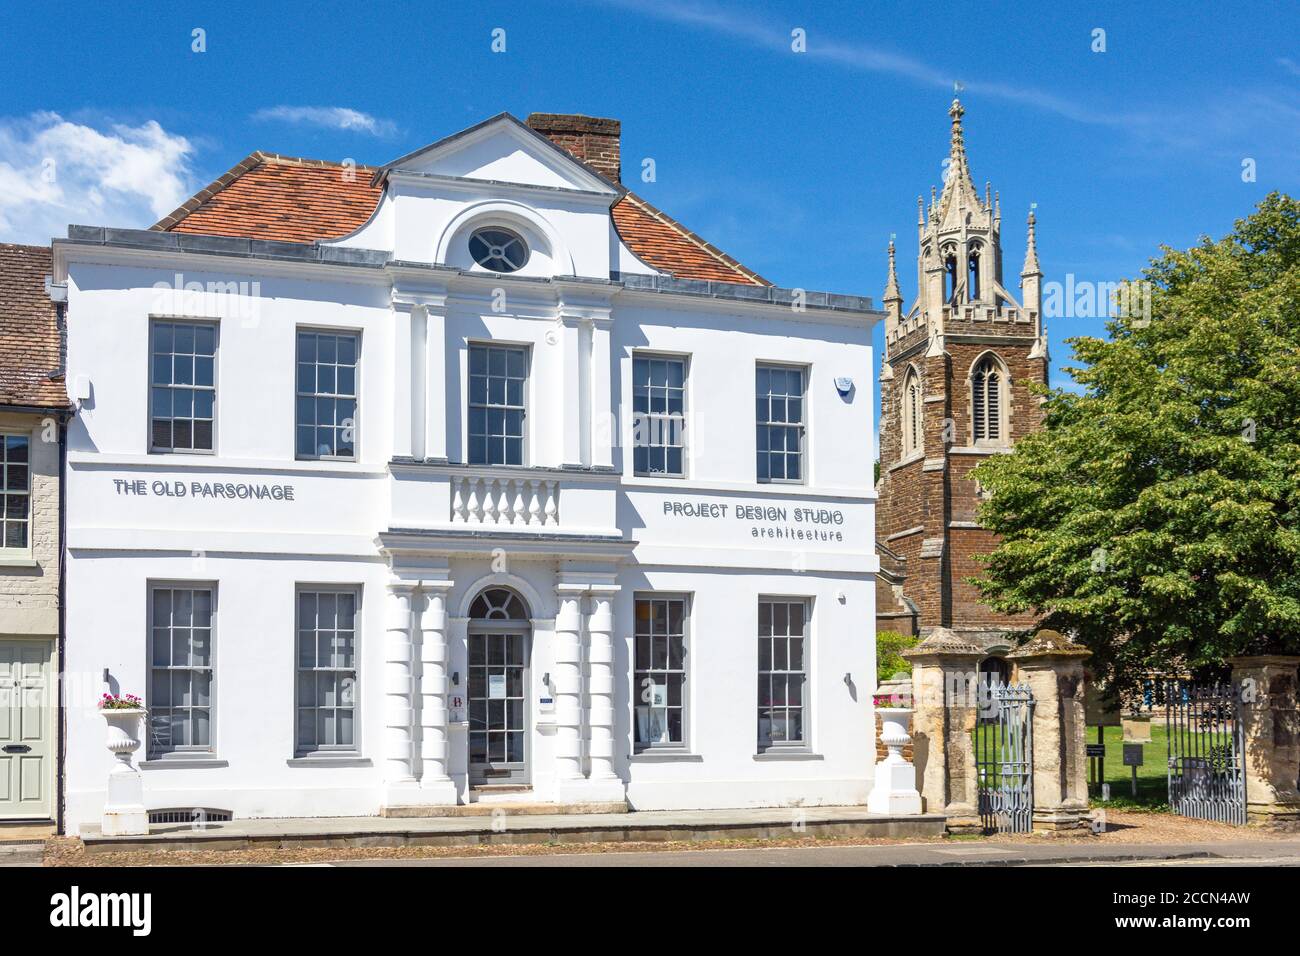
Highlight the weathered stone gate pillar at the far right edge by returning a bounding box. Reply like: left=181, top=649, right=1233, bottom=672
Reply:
left=1229, top=654, right=1300, bottom=829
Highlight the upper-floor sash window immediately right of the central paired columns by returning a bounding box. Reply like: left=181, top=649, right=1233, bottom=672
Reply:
left=632, top=355, right=686, bottom=477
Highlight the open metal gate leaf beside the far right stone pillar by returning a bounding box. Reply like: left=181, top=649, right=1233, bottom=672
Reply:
left=1165, top=680, right=1245, bottom=823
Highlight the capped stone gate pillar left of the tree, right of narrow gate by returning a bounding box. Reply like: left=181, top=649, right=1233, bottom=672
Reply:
left=1006, top=631, right=1092, bottom=832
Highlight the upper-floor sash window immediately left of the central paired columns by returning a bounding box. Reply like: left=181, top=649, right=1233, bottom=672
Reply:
left=295, top=329, right=360, bottom=460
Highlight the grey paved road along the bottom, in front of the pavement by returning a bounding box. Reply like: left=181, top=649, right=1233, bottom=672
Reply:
left=319, top=840, right=1300, bottom=866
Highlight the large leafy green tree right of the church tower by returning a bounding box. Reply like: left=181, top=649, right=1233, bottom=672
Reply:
left=975, top=194, right=1300, bottom=684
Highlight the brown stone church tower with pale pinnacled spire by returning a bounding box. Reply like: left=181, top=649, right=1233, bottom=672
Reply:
left=876, top=100, right=1048, bottom=652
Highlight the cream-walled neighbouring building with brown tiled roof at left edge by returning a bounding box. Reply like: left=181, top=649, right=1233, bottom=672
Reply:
left=0, top=245, right=68, bottom=835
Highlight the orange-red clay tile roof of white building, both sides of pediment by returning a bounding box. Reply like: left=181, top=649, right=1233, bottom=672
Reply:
left=152, top=152, right=771, bottom=285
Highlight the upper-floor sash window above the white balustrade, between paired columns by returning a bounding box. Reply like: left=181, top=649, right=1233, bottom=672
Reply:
left=468, top=345, right=528, bottom=464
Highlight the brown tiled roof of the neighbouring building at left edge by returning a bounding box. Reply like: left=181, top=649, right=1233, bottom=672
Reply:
left=0, top=243, right=68, bottom=408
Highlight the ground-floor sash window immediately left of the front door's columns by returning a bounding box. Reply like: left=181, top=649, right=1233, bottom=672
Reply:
left=295, top=588, right=359, bottom=757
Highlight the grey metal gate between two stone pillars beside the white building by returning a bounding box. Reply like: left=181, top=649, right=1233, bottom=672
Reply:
left=974, top=683, right=1034, bottom=834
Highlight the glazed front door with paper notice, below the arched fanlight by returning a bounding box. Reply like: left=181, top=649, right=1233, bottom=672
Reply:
left=469, top=632, right=528, bottom=783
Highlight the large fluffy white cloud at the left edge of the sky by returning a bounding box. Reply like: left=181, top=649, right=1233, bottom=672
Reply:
left=0, top=113, right=194, bottom=245
